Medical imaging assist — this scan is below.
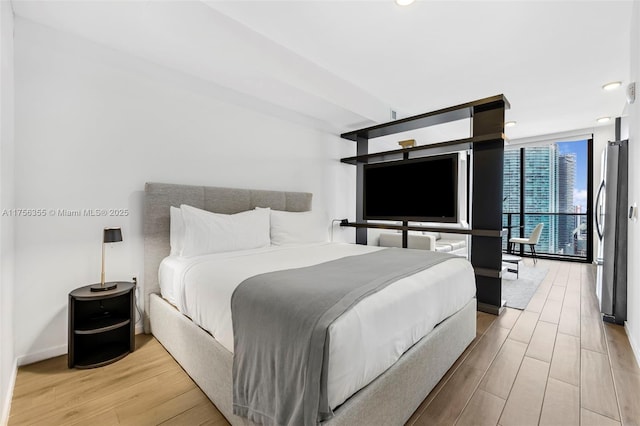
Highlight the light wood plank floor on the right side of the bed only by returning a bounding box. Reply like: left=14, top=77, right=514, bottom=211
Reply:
left=408, top=259, right=640, bottom=426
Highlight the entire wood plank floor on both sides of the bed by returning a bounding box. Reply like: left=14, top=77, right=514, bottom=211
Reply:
left=9, top=260, right=640, bottom=426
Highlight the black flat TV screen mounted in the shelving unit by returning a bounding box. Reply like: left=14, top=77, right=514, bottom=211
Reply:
left=363, top=153, right=458, bottom=223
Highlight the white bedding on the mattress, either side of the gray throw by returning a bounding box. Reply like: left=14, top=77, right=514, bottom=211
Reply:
left=159, top=243, right=476, bottom=408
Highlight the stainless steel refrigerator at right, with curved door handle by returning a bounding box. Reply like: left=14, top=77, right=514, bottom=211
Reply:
left=595, top=140, right=629, bottom=324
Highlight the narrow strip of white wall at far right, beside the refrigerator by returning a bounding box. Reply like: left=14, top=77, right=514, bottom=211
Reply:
left=626, top=2, right=640, bottom=364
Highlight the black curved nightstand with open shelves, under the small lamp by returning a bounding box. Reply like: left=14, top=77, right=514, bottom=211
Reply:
left=68, top=282, right=136, bottom=368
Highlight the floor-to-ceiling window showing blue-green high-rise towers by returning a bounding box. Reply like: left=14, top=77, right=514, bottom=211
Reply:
left=503, top=140, right=593, bottom=262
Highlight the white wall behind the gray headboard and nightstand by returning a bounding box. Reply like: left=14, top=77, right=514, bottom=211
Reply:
left=14, top=19, right=355, bottom=363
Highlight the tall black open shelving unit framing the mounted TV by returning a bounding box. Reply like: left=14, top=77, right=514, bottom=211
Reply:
left=341, top=95, right=510, bottom=315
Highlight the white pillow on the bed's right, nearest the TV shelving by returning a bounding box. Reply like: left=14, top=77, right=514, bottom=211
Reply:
left=271, top=210, right=328, bottom=246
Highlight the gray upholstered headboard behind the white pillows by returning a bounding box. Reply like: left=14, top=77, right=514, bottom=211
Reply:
left=143, top=183, right=313, bottom=333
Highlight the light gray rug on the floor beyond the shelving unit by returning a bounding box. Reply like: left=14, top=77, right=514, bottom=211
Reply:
left=502, top=262, right=549, bottom=309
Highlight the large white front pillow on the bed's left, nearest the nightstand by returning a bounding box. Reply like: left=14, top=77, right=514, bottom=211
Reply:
left=180, top=204, right=270, bottom=257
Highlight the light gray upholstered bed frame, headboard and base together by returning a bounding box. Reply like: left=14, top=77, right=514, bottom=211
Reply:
left=144, top=183, right=476, bottom=425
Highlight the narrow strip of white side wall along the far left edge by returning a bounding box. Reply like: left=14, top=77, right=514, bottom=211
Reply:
left=0, top=1, right=16, bottom=424
